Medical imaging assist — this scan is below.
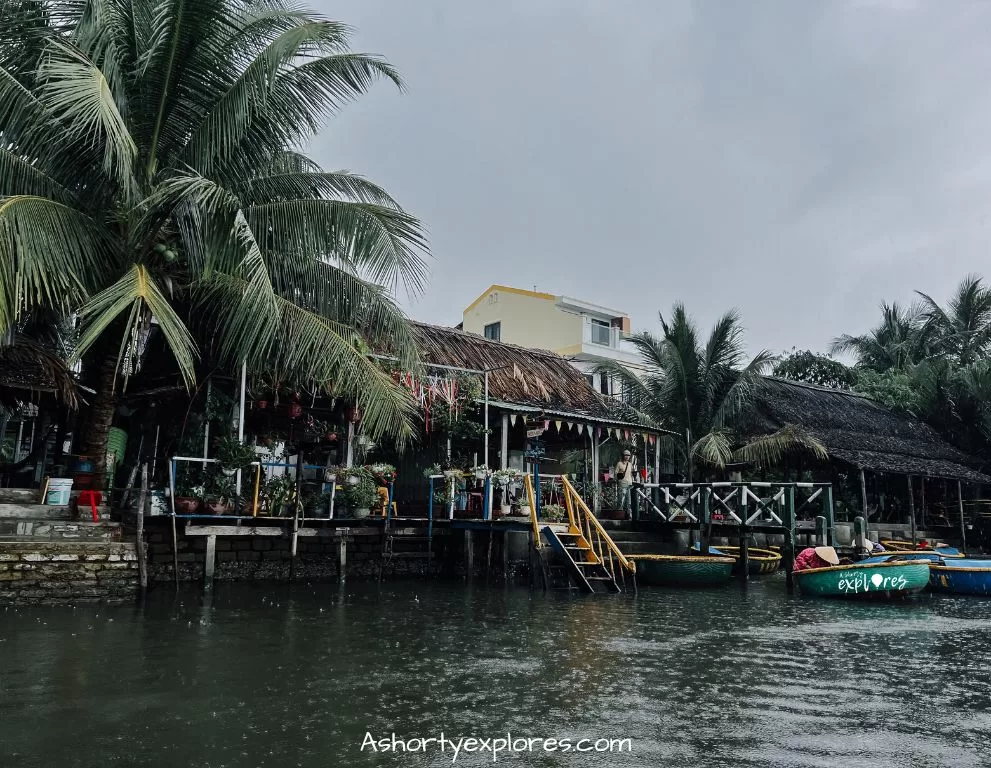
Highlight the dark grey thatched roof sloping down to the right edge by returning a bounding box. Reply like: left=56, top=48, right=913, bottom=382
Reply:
left=758, top=377, right=991, bottom=483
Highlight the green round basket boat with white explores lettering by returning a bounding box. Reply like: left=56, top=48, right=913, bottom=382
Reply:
left=794, top=560, right=929, bottom=600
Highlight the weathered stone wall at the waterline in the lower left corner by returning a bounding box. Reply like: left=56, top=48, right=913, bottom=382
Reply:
left=0, top=541, right=138, bottom=605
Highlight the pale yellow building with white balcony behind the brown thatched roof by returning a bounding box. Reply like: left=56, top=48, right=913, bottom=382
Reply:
left=462, top=285, right=639, bottom=395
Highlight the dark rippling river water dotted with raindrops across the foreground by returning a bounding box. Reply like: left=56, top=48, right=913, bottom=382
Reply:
left=0, top=578, right=991, bottom=768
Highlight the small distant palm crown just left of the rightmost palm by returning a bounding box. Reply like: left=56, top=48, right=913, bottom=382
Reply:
left=830, top=303, right=931, bottom=371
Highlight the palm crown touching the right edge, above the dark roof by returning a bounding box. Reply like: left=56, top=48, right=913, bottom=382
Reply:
left=917, top=275, right=991, bottom=365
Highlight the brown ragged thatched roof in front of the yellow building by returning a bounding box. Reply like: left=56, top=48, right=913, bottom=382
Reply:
left=406, top=323, right=661, bottom=432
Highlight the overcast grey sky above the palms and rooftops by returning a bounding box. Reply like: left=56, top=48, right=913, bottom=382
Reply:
left=310, top=0, right=991, bottom=351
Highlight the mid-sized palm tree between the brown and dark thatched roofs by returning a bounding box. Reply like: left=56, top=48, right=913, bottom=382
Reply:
left=601, top=303, right=826, bottom=481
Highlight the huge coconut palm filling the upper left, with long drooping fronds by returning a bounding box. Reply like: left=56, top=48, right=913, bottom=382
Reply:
left=0, top=0, right=426, bottom=472
